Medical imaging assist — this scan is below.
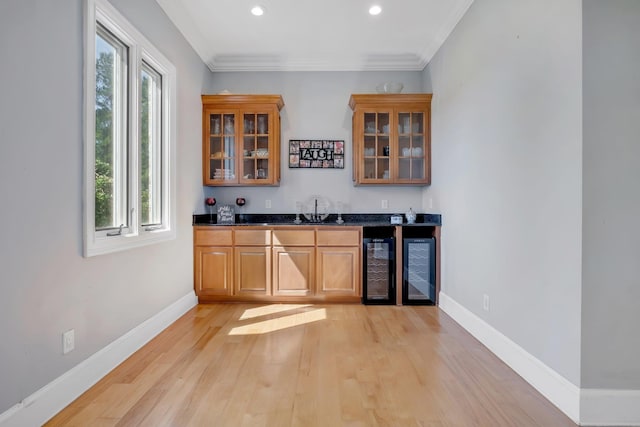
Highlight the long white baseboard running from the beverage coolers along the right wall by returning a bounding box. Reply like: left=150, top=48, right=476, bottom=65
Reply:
left=439, top=292, right=580, bottom=423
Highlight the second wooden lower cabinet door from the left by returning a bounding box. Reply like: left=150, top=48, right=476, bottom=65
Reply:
left=234, top=246, right=271, bottom=297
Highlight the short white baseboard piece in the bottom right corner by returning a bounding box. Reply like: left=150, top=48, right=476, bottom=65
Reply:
left=580, top=388, right=640, bottom=426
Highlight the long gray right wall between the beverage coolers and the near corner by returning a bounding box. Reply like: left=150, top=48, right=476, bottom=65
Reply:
left=424, top=0, right=582, bottom=385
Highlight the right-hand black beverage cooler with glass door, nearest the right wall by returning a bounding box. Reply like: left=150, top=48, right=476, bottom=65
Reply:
left=402, top=237, right=436, bottom=305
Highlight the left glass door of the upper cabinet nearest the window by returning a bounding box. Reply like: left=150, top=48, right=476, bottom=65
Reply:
left=208, top=113, right=236, bottom=181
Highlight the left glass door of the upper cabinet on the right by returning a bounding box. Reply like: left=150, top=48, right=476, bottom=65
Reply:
left=362, top=112, right=391, bottom=182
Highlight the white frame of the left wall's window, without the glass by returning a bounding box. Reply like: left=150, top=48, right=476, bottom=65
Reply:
left=83, top=0, right=176, bottom=257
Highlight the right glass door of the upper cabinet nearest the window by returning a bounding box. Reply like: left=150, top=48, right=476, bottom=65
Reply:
left=241, top=113, right=276, bottom=181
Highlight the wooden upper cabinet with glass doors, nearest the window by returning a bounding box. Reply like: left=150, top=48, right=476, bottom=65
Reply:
left=202, top=95, right=284, bottom=186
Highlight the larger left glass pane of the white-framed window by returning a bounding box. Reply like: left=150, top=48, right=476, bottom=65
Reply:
left=95, top=26, right=128, bottom=230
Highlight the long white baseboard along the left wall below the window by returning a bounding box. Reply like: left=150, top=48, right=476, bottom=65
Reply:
left=0, top=292, right=198, bottom=427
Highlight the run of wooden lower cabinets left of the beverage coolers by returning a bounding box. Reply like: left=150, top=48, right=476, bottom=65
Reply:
left=194, top=226, right=362, bottom=302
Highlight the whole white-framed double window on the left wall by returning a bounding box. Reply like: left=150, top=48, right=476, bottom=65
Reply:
left=84, top=0, right=175, bottom=256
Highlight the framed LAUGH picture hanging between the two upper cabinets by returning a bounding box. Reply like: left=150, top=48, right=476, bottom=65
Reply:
left=289, top=139, right=344, bottom=169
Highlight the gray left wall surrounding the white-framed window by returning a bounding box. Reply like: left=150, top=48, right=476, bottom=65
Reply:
left=0, top=0, right=211, bottom=413
